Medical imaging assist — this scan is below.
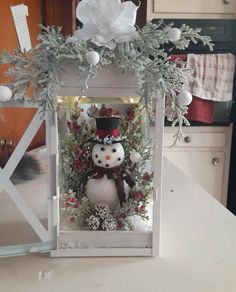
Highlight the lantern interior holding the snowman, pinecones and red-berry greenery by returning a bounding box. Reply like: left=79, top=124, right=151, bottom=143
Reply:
left=58, top=96, right=158, bottom=249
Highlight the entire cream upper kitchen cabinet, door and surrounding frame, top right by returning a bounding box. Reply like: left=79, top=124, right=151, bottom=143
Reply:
left=147, top=0, right=236, bottom=20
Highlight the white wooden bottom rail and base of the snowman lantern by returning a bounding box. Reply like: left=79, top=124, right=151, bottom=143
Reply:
left=50, top=231, right=156, bottom=257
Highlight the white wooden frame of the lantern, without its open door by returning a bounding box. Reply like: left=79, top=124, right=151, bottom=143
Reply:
left=50, top=67, right=164, bottom=257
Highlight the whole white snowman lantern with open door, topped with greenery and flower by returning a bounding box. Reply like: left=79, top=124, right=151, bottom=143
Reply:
left=0, top=0, right=210, bottom=257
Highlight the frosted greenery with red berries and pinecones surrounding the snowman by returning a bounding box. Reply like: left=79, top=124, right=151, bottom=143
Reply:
left=60, top=102, right=153, bottom=230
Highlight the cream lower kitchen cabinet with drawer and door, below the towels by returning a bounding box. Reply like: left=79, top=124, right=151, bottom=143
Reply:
left=164, top=126, right=232, bottom=205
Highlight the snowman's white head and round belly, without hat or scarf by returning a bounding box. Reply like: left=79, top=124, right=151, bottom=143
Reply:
left=87, top=143, right=127, bottom=208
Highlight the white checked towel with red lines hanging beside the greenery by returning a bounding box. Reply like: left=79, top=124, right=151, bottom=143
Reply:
left=187, top=53, right=235, bottom=101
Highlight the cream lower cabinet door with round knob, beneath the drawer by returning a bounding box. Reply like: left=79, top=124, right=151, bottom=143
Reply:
left=164, top=150, right=224, bottom=202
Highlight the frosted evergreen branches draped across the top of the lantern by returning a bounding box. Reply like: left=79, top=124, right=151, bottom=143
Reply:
left=0, top=21, right=213, bottom=137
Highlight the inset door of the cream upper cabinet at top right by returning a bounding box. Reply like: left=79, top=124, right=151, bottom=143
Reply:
left=154, top=0, right=236, bottom=14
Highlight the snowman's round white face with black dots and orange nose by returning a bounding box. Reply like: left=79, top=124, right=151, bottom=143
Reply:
left=92, top=143, right=124, bottom=168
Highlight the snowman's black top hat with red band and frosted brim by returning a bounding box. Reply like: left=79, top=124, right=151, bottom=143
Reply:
left=91, top=106, right=124, bottom=144
